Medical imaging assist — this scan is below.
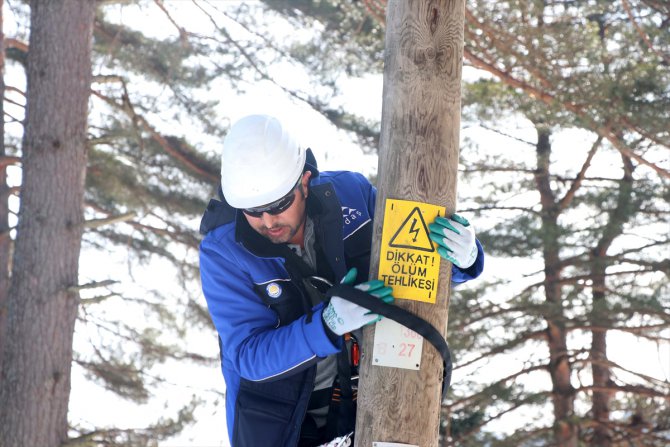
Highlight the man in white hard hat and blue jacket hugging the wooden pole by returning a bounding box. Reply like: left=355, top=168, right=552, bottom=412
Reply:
left=200, top=115, right=484, bottom=447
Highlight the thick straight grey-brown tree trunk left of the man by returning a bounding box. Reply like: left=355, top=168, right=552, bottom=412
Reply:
left=0, top=0, right=96, bottom=447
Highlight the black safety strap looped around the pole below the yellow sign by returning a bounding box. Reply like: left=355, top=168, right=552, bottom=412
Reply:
left=326, top=284, right=452, bottom=399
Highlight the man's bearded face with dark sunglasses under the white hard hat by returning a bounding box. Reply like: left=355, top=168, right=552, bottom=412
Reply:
left=243, top=171, right=311, bottom=245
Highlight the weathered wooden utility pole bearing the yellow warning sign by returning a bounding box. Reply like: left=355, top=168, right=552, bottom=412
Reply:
left=356, top=0, right=465, bottom=447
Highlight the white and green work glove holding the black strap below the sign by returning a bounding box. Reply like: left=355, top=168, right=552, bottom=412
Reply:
left=321, top=268, right=394, bottom=335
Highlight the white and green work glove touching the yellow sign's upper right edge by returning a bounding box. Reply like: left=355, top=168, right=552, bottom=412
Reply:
left=428, top=214, right=477, bottom=269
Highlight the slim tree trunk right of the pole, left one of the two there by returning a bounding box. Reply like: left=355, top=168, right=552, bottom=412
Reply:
left=535, top=125, right=578, bottom=447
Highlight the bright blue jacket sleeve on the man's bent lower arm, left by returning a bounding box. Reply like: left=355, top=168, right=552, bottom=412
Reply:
left=200, top=238, right=339, bottom=381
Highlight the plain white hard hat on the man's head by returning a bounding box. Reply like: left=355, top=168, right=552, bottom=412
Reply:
left=221, top=115, right=305, bottom=208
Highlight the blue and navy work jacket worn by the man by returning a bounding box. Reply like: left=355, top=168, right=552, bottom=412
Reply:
left=200, top=169, right=484, bottom=447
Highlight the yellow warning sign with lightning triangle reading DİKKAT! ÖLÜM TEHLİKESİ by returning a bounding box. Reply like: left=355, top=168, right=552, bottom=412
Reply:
left=379, top=199, right=444, bottom=303
